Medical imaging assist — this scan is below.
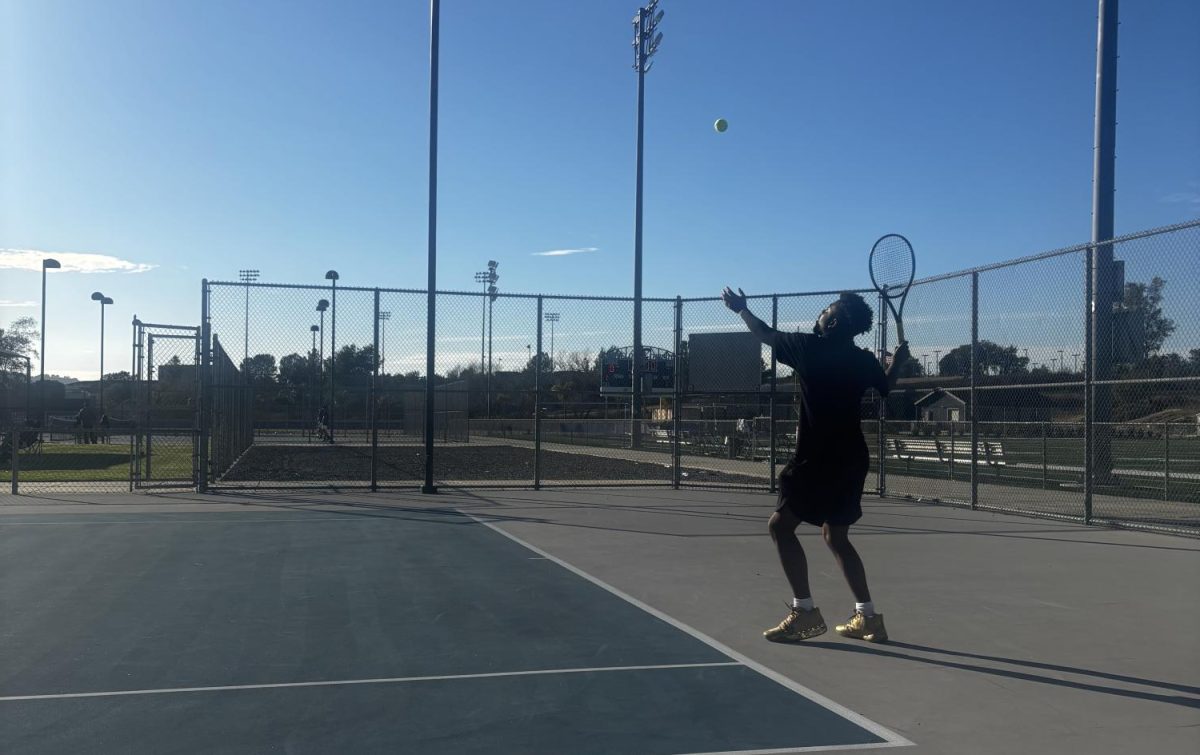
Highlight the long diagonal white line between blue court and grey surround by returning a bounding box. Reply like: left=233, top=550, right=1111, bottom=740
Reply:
left=458, top=509, right=914, bottom=755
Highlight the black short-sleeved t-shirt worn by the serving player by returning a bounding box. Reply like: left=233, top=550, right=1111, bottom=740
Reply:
left=774, top=332, right=888, bottom=465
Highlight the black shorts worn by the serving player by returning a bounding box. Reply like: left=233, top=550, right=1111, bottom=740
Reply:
left=775, top=459, right=868, bottom=527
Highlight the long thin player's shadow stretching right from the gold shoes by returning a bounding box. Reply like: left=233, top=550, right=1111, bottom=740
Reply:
left=804, top=641, right=1200, bottom=708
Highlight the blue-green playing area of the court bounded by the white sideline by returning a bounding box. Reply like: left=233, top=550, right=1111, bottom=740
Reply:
left=0, top=497, right=910, bottom=754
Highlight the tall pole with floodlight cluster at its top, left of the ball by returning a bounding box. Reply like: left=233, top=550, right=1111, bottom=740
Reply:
left=629, top=0, right=662, bottom=448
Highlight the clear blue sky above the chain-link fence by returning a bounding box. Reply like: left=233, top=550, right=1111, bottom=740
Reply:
left=0, top=0, right=1200, bottom=377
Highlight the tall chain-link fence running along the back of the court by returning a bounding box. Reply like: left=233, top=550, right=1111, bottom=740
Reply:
left=0, top=222, right=1200, bottom=534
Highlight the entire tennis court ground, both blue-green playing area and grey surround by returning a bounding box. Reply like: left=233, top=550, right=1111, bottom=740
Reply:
left=0, top=490, right=1200, bottom=754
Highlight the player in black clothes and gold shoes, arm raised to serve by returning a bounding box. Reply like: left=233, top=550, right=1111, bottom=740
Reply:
left=721, top=288, right=908, bottom=642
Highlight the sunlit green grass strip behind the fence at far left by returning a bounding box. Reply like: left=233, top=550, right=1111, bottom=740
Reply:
left=0, top=438, right=192, bottom=483
